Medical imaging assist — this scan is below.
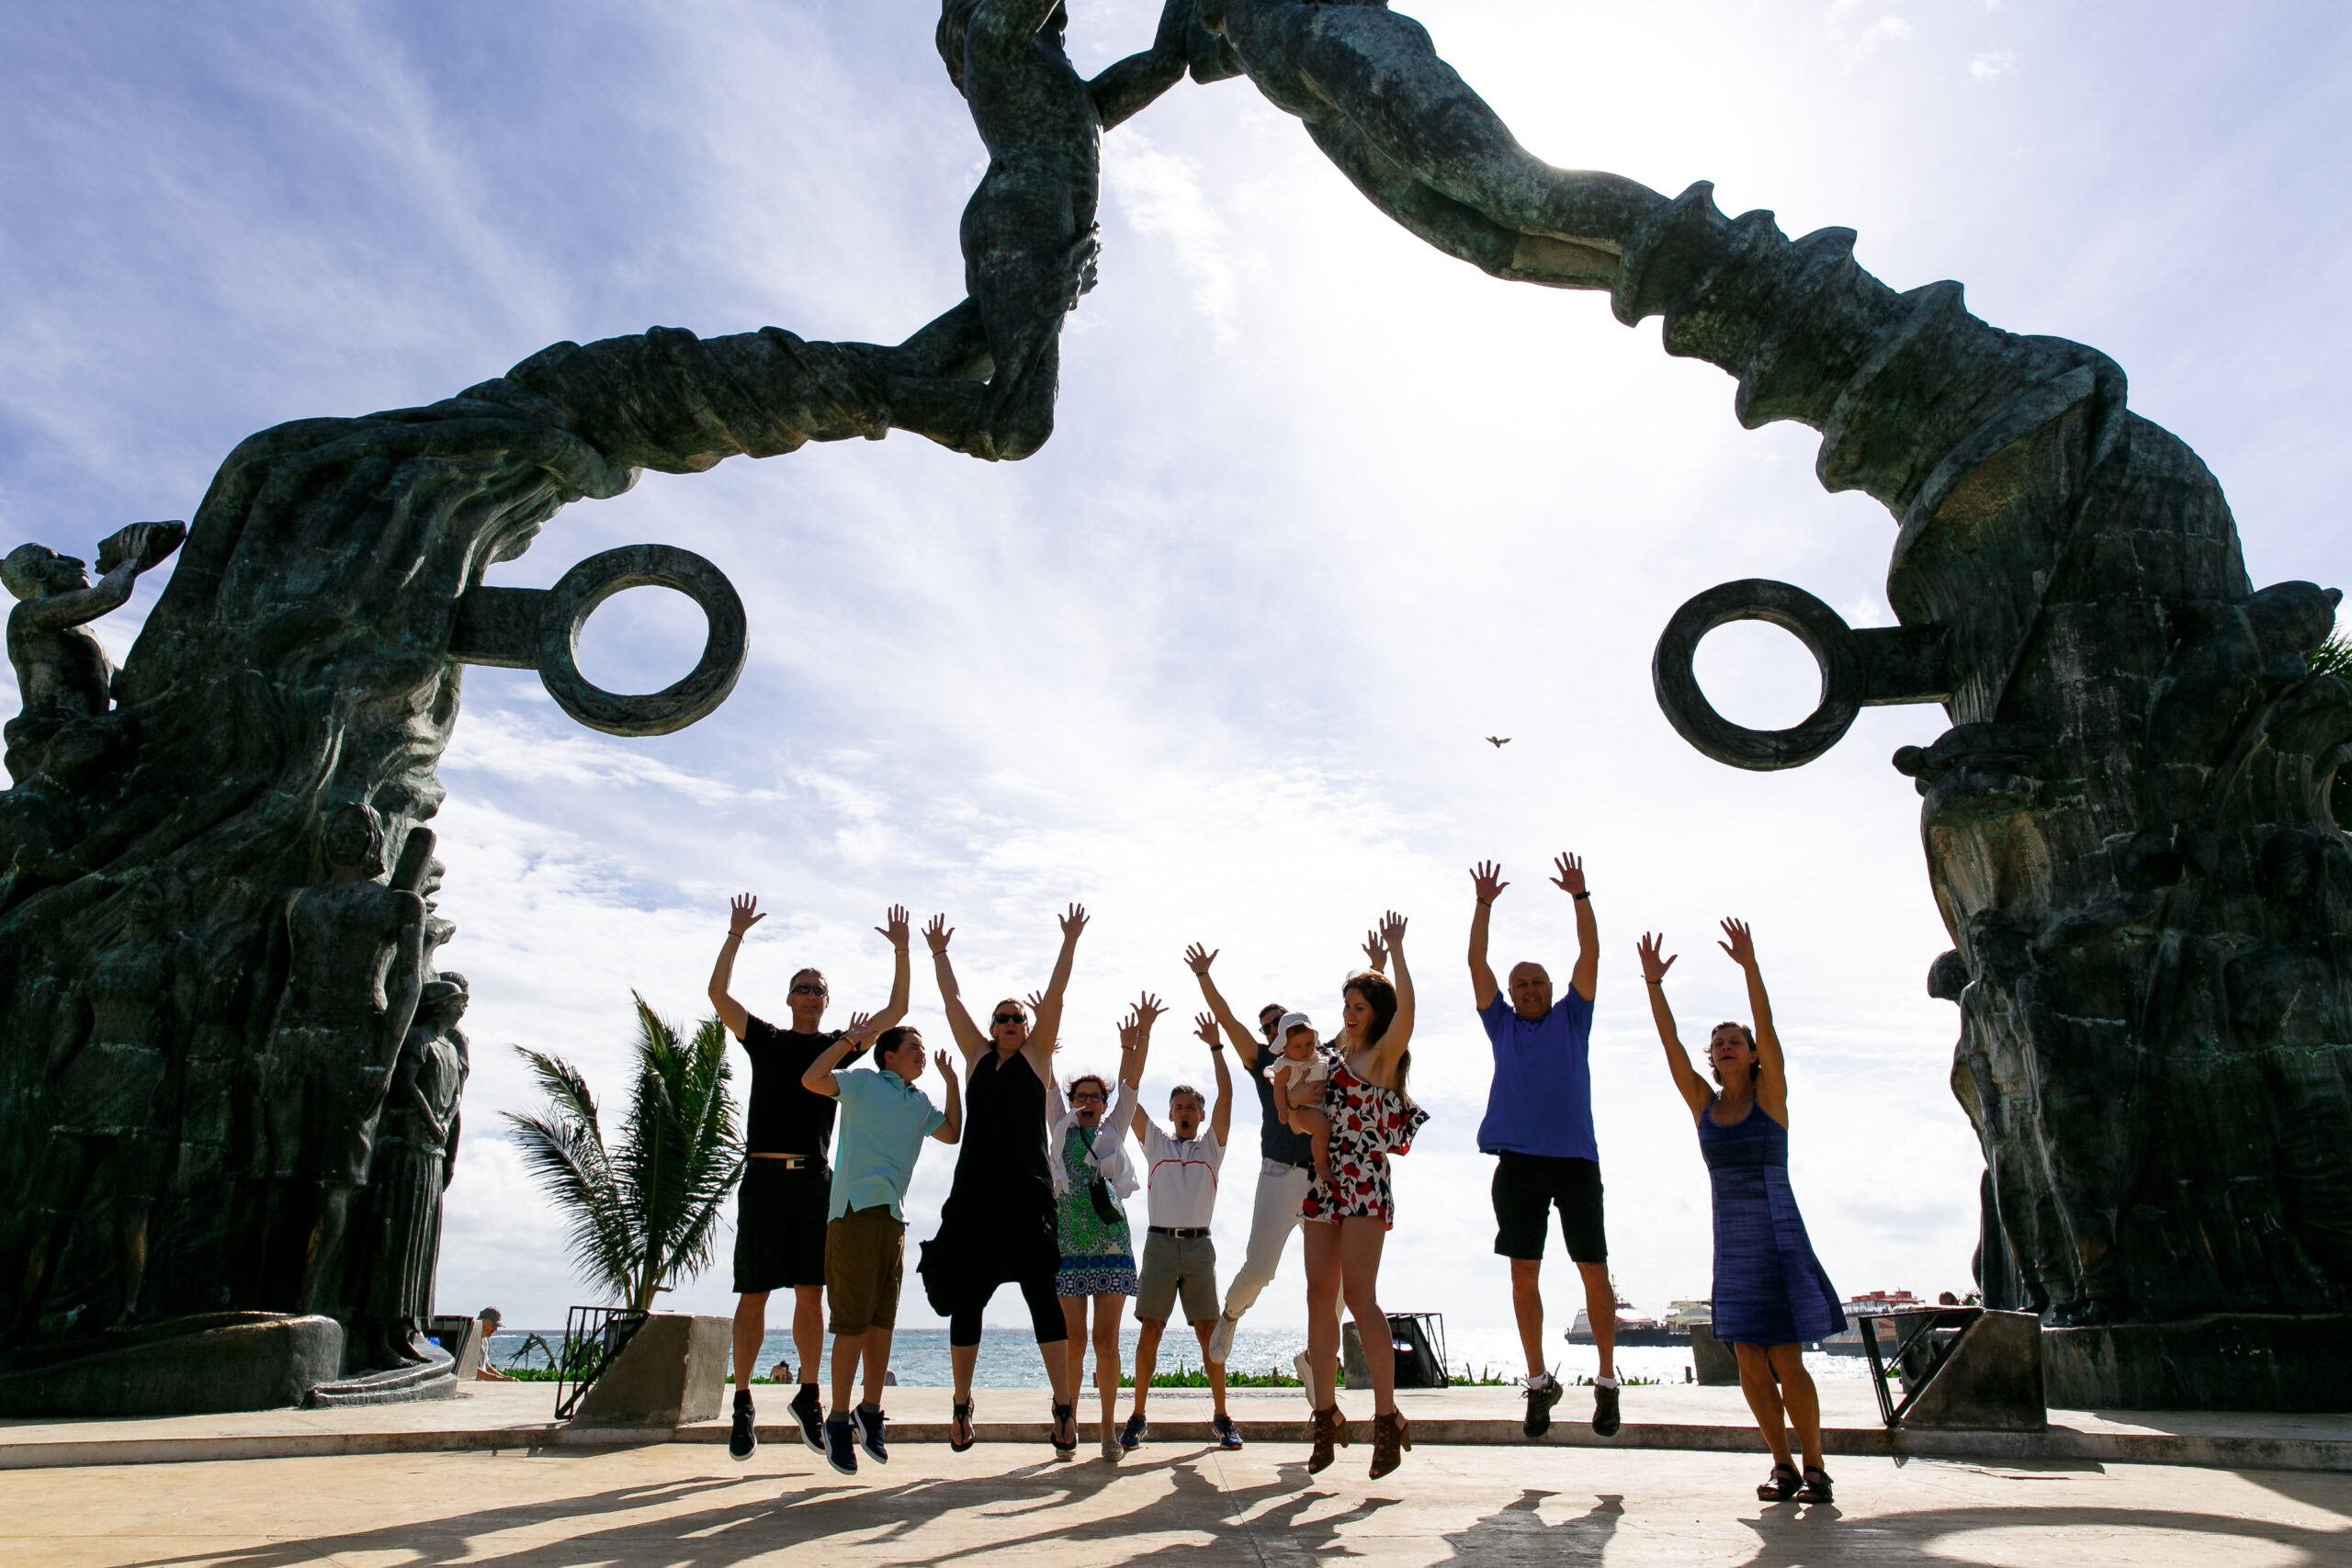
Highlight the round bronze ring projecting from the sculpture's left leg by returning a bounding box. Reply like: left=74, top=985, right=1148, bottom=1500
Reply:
left=538, top=546, right=751, bottom=736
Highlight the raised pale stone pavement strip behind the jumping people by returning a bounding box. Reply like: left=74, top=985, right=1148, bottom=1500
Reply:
left=0, top=1380, right=2352, bottom=1472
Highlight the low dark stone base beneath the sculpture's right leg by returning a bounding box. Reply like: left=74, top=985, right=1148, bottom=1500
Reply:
left=2041, top=1312, right=2352, bottom=1413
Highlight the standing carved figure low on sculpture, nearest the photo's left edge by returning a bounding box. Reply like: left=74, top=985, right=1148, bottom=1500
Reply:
left=9, top=870, right=198, bottom=1342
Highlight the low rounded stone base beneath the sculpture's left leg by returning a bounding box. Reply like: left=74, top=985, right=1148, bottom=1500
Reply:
left=0, top=1312, right=344, bottom=1416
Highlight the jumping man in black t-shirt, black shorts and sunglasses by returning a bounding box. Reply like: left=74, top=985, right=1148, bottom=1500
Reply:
left=710, top=894, right=908, bottom=1460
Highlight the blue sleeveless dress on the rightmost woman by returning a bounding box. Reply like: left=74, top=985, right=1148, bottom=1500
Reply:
left=1698, top=1098, right=1847, bottom=1345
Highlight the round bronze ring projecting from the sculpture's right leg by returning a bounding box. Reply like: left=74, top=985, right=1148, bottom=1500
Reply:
left=1649, top=579, right=1863, bottom=771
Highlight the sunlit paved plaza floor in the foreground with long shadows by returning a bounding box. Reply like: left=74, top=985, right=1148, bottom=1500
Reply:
left=0, top=1441, right=2352, bottom=1568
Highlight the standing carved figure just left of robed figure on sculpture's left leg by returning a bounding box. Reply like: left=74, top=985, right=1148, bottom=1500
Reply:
left=259, top=802, right=425, bottom=1312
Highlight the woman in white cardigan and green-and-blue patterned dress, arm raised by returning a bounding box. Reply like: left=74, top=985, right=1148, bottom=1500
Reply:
left=1046, top=997, right=1159, bottom=1464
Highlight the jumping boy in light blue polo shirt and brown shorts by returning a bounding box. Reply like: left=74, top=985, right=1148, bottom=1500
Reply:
left=799, top=1025, right=965, bottom=1476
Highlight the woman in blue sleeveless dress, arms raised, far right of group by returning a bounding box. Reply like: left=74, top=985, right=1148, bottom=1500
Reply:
left=1642, top=919, right=1847, bottom=1502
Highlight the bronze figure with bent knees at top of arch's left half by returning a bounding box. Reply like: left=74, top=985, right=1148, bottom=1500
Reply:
left=877, top=0, right=1197, bottom=458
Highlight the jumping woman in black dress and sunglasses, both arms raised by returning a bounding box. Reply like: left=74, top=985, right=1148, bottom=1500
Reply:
left=920, top=903, right=1087, bottom=1458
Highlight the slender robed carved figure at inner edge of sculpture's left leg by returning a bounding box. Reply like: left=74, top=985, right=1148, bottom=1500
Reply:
left=356, top=974, right=468, bottom=1366
